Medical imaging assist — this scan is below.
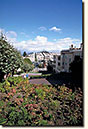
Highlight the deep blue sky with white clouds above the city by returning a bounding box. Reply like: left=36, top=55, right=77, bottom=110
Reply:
left=0, top=0, right=82, bottom=53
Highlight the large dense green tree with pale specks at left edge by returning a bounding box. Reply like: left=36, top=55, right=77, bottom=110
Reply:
left=0, top=35, right=23, bottom=81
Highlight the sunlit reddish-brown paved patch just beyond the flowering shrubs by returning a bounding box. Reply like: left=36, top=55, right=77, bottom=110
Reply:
left=29, top=78, right=51, bottom=85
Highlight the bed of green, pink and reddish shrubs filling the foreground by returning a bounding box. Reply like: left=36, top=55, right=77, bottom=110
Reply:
left=0, top=77, right=83, bottom=126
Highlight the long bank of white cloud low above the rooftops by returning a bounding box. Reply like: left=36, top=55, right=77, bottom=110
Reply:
left=0, top=28, right=81, bottom=52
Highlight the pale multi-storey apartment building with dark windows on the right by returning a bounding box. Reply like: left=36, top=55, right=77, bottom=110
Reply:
left=50, top=44, right=83, bottom=73
